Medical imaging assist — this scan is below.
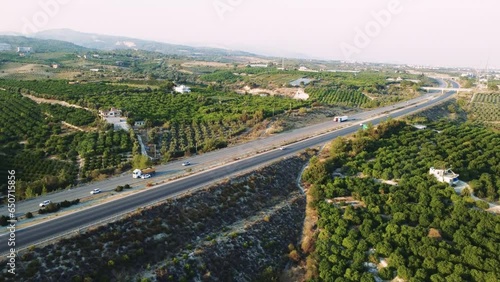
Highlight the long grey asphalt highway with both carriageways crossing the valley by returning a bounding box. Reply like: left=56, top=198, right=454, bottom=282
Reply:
left=0, top=80, right=454, bottom=254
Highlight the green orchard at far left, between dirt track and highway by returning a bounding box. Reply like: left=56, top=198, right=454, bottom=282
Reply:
left=0, top=90, right=132, bottom=200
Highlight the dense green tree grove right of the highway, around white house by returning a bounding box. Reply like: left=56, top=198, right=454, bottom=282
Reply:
left=304, top=121, right=500, bottom=281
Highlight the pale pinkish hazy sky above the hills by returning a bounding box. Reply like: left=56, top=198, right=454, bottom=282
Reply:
left=0, top=0, right=500, bottom=68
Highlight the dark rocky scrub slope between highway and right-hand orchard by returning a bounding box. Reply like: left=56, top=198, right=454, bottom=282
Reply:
left=0, top=155, right=308, bottom=281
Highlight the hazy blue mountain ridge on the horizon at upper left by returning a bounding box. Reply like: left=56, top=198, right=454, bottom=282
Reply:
left=31, top=29, right=256, bottom=57
